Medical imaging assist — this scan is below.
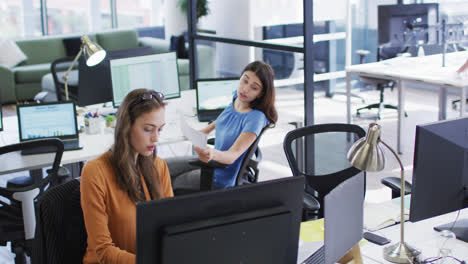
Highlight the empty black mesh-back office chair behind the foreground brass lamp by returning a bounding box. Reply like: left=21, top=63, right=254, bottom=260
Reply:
left=283, top=124, right=366, bottom=221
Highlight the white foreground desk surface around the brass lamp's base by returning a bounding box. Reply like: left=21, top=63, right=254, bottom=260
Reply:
left=361, top=209, right=468, bottom=263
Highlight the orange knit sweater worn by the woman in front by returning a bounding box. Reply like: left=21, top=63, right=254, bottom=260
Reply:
left=81, top=152, right=174, bottom=264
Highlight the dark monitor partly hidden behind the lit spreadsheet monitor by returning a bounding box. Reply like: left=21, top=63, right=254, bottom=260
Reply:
left=76, top=47, right=153, bottom=106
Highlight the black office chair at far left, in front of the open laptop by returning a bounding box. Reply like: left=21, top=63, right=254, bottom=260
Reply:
left=0, top=139, right=63, bottom=264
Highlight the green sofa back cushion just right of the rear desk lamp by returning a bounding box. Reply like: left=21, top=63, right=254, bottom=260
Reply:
left=96, top=30, right=138, bottom=51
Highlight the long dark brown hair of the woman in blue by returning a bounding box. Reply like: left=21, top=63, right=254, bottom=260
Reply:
left=242, top=61, right=278, bottom=127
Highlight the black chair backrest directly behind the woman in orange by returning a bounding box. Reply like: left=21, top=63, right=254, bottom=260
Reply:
left=31, top=178, right=87, bottom=264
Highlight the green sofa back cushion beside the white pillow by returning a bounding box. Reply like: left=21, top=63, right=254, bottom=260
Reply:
left=16, top=37, right=66, bottom=65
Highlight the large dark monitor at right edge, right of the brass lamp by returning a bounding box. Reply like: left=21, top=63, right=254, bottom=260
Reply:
left=409, top=118, right=468, bottom=242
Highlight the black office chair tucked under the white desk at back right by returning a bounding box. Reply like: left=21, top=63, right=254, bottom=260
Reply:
left=356, top=46, right=408, bottom=120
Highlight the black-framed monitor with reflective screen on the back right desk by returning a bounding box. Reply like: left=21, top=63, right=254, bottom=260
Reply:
left=378, top=3, right=439, bottom=47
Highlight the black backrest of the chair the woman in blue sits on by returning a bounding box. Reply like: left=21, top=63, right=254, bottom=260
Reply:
left=236, top=126, right=269, bottom=185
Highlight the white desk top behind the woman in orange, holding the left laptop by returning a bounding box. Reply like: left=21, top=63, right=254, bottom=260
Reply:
left=0, top=91, right=204, bottom=175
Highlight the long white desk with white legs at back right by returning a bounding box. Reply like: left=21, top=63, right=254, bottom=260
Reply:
left=346, top=51, right=468, bottom=154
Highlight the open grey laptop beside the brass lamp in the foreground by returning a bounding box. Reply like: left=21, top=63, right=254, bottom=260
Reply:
left=301, top=173, right=364, bottom=264
